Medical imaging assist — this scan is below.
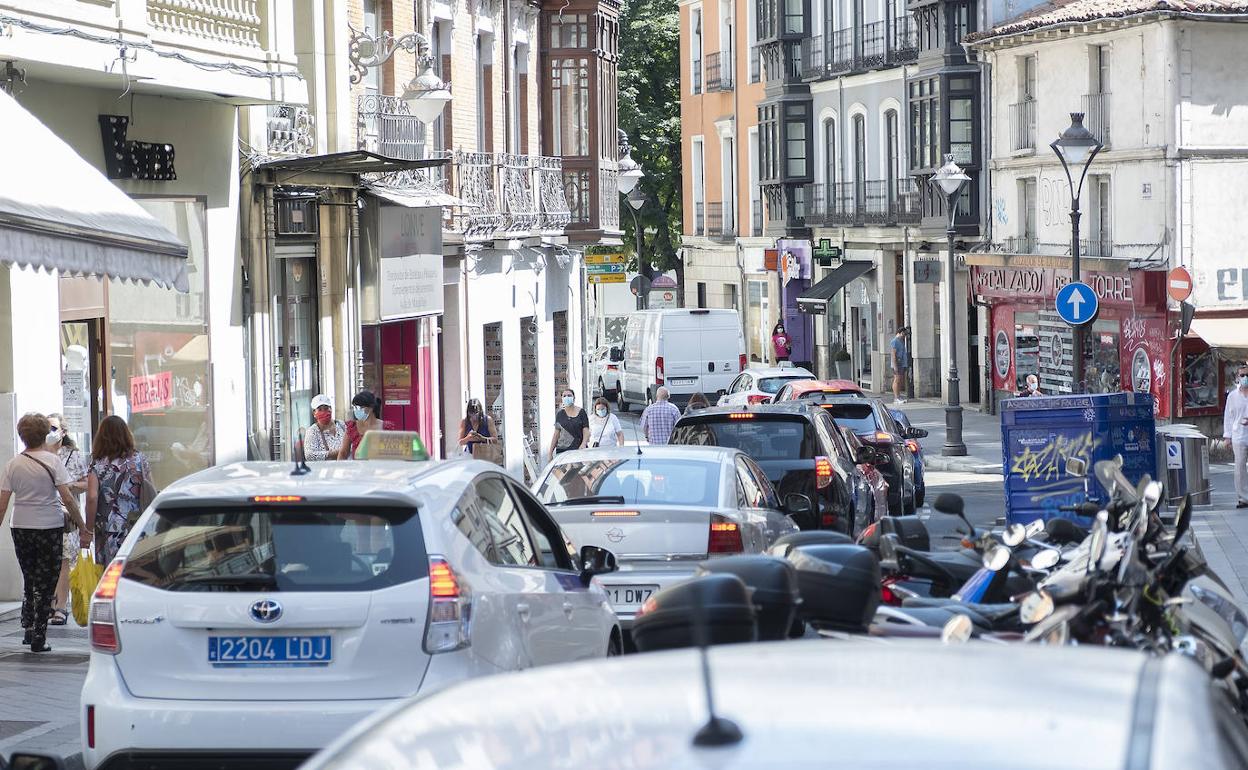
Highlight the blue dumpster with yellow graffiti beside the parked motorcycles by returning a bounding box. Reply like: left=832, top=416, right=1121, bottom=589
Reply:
left=1001, top=393, right=1156, bottom=524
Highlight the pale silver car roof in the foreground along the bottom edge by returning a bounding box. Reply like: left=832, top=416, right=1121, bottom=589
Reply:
left=305, top=639, right=1218, bottom=770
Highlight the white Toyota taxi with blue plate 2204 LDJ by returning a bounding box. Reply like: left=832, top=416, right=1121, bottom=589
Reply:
left=81, top=431, right=622, bottom=769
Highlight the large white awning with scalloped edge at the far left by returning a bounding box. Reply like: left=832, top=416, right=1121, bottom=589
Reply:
left=0, top=91, right=190, bottom=292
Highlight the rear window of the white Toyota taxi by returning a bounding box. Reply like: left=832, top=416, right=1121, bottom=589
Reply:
left=121, top=507, right=429, bottom=592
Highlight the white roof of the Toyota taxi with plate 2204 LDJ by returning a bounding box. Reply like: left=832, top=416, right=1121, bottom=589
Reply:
left=147, top=459, right=476, bottom=508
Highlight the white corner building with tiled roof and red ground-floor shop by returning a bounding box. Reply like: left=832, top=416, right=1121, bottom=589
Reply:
left=967, top=0, right=1248, bottom=421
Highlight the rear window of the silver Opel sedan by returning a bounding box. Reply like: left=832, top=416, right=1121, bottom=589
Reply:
left=538, top=456, right=720, bottom=507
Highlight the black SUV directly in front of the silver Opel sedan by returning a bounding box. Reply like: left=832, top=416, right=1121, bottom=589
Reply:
left=669, top=402, right=875, bottom=534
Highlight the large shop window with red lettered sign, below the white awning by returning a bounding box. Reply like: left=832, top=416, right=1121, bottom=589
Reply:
left=109, top=198, right=216, bottom=489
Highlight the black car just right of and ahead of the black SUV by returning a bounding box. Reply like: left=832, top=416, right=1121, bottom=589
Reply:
left=820, top=396, right=916, bottom=515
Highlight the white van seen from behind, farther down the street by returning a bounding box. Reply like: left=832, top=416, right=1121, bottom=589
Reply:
left=615, top=308, right=745, bottom=412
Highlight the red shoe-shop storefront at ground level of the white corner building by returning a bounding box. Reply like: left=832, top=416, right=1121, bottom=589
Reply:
left=971, top=265, right=1174, bottom=417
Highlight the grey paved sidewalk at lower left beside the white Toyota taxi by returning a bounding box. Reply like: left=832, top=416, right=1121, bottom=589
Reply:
left=0, top=603, right=91, bottom=770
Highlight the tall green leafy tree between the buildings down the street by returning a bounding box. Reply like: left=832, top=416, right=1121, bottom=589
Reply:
left=619, top=0, right=683, bottom=279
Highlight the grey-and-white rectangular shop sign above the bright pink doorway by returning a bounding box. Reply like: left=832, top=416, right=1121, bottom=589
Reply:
left=378, top=206, right=442, bottom=321
